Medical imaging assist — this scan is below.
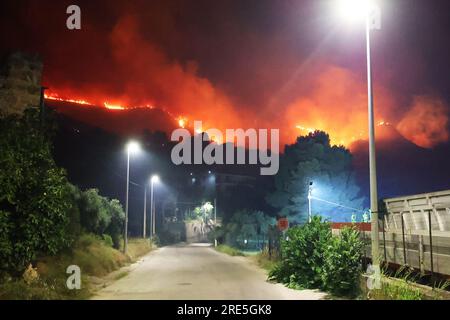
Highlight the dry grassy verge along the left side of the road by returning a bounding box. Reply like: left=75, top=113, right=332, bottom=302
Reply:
left=0, top=234, right=152, bottom=300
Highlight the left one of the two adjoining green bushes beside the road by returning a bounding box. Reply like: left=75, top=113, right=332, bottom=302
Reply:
left=269, top=216, right=332, bottom=289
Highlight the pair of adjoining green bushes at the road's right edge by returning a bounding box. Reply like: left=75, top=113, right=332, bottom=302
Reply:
left=269, top=216, right=363, bottom=295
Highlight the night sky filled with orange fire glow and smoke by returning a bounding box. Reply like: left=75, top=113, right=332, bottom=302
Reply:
left=0, top=0, right=450, bottom=199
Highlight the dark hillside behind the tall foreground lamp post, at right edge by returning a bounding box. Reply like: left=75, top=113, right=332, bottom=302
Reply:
left=351, top=122, right=450, bottom=202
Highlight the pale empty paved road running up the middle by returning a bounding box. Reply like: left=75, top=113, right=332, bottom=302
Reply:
left=94, top=244, right=325, bottom=300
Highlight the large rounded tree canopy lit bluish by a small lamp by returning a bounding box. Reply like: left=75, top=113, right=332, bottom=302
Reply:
left=267, top=131, right=364, bottom=223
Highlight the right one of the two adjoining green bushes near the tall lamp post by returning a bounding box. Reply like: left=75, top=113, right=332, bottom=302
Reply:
left=322, top=228, right=364, bottom=295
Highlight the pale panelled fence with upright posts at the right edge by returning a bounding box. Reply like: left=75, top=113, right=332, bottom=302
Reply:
left=333, top=190, right=450, bottom=276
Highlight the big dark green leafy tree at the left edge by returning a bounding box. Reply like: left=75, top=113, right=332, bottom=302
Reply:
left=0, top=109, right=72, bottom=273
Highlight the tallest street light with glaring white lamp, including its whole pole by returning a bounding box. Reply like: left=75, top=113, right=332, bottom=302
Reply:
left=339, top=0, right=381, bottom=269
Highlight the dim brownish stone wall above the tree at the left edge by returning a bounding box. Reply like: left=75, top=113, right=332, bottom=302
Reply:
left=0, top=52, right=43, bottom=116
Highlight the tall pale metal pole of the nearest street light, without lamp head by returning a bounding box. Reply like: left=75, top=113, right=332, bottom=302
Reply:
left=366, top=15, right=380, bottom=269
